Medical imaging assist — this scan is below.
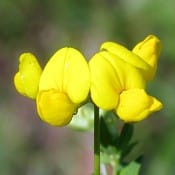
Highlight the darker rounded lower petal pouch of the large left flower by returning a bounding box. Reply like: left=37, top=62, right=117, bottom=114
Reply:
left=37, top=89, right=77, bottom=126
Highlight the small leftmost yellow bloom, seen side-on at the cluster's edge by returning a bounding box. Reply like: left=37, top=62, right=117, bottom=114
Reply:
left=14, top=53, right=42, bottom=99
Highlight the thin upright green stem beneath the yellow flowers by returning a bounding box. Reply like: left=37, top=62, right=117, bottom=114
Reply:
left=94, top=104, right=100, bottom=175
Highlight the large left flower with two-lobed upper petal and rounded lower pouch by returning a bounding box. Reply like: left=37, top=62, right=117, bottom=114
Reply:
left=37, top=48, right=90, bottom=126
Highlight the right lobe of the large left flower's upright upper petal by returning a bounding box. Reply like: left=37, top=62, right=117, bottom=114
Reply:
left=64, top=49, right=90, bottom=103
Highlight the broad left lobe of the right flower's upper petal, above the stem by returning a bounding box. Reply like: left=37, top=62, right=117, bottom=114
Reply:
left=89, top=52, right=122, bottom=110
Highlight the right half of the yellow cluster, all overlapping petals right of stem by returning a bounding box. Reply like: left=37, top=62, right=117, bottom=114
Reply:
left=89, top=35, right=162, bottom=122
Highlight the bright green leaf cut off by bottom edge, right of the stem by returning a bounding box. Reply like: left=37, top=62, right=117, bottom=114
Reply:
left=118, top=161, right=141, bottom=175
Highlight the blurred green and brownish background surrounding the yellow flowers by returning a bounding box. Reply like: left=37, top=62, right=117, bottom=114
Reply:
left=0, top=0, right=175, bottom=175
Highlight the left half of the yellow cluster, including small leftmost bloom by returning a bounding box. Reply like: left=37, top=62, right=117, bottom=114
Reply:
left=14, top=47, right=90, bottom=126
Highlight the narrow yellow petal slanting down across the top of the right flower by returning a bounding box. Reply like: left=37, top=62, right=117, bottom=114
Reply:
left=101, top=42, right=150, bottom=71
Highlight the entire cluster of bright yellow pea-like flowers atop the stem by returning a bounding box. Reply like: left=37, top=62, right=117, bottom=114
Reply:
left=14, top=35, right=162, bottom=126
